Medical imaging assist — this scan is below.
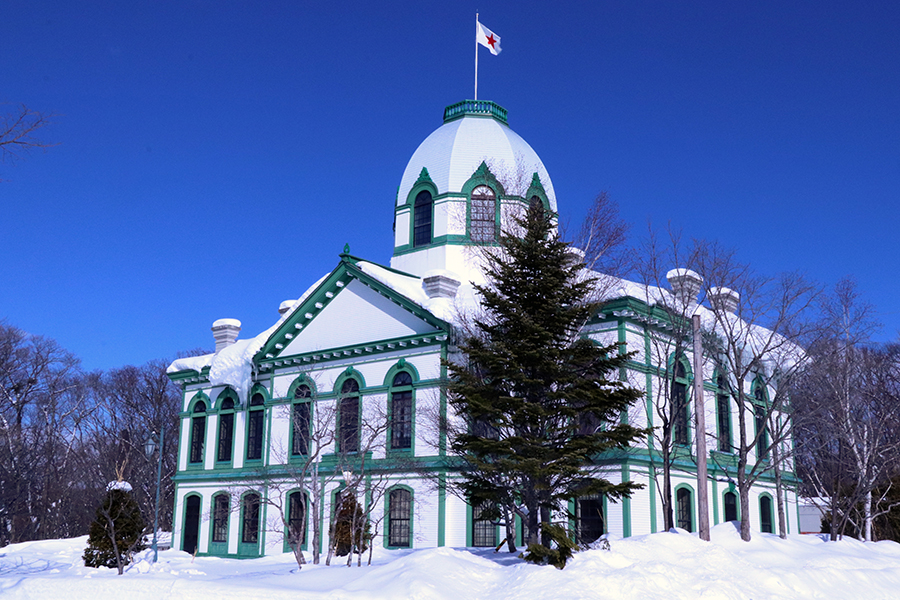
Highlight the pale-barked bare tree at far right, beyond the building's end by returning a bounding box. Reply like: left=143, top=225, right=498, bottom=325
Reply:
left=793, top=279, right=900, bottom=541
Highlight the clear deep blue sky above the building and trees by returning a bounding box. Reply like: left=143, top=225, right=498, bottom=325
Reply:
left=0, top=0, right=900, bottom=369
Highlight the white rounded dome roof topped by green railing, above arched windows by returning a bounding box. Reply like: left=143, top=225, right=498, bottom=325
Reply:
left=397, top=100, right=556, bottom=212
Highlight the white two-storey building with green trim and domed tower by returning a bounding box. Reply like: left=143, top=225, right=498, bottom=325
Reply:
left=169, top=101, right=797, bottom=557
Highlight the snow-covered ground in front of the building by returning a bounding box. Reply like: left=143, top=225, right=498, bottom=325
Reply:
left=0, top=524, right=900, bottom=600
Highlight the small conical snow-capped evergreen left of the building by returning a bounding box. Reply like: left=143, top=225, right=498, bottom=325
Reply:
left=83, top=486, right=146, bottom=575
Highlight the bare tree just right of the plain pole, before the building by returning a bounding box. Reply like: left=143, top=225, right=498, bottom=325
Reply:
left=697, top=244, right=821, bottom=541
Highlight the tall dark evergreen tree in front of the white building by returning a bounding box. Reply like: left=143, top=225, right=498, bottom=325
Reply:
left=446, top=205, right=646, bottom=568
